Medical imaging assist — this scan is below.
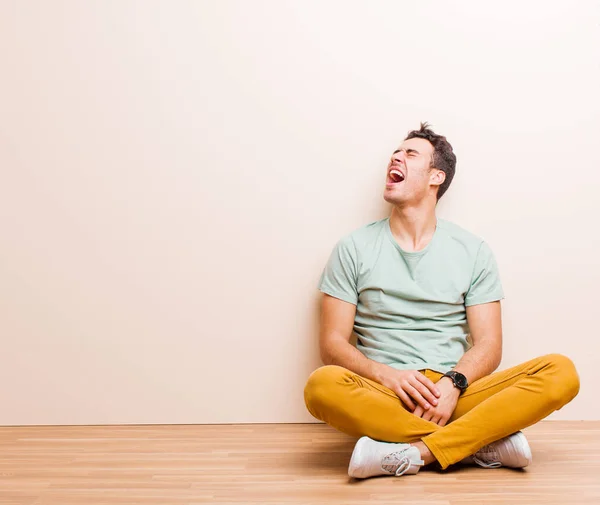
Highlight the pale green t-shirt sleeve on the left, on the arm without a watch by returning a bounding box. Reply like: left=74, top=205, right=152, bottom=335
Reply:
left=319, top=237, right=358, bottom=305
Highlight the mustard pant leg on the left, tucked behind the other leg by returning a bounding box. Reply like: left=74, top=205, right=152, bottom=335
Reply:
left=304, top=365, right=442, bottom=442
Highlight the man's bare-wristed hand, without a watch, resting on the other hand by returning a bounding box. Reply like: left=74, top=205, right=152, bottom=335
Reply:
left=380, top=367, right=440, bottom=412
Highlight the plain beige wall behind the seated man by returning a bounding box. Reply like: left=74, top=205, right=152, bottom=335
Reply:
left=0, top=0, right=600, bottom=425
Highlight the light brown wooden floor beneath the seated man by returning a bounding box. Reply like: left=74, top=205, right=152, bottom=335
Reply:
left=0, top=421, right=600, bottom=505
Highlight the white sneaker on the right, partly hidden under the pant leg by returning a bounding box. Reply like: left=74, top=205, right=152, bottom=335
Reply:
left=461, top=431, right=532, bottom=468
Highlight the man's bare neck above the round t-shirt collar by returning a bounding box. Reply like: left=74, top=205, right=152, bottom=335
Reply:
left=390, top=202, right=437, bottom=252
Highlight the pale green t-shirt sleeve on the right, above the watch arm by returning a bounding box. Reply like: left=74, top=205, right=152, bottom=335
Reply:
left=465, top=242, right=504, bottom=307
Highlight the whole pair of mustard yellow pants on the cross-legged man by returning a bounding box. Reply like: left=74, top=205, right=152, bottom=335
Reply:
left=304, top=354, right=579, bottom=469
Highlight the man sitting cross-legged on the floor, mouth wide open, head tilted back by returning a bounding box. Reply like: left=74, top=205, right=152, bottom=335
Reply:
left=304, top=123, right=579, bottom=478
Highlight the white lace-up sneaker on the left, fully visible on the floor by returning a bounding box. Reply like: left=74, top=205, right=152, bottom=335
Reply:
left=348, top=437, right=424, bottom=479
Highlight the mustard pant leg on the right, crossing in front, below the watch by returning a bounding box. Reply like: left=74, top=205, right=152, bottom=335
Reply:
left=423, top=354, right=579, bottom=468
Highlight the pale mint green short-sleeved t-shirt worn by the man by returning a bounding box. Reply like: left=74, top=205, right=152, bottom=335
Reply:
left=319, top=218, right=504, bottom=373
